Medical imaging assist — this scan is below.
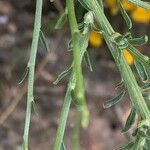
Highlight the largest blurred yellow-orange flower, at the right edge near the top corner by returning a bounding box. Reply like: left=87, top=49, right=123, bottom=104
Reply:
left=131, top=7, right=150, bottom=23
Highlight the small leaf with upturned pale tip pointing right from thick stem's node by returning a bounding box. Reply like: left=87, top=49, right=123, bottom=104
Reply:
left=128, top=35, right=148, bottom=46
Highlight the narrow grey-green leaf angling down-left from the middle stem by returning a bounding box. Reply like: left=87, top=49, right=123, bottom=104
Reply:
left=53, top=65, right=73, bottom=85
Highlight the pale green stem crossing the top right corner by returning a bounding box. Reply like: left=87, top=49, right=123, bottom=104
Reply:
left=128, top=0, right=150, bottom=10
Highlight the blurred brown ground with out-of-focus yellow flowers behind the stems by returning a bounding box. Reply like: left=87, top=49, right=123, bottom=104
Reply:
left=0, top=0, right=150, bottom=150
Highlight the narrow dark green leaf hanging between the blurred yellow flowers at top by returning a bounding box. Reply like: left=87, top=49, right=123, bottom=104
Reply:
left=117, top=0, right=132, bottom=29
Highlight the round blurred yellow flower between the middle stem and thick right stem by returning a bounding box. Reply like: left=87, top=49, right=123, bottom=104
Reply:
left=89, top=31, right=103, bottom=47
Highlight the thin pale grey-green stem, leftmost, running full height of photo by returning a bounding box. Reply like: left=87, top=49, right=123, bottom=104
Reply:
left=23, top=0, right=43, bottom=150
